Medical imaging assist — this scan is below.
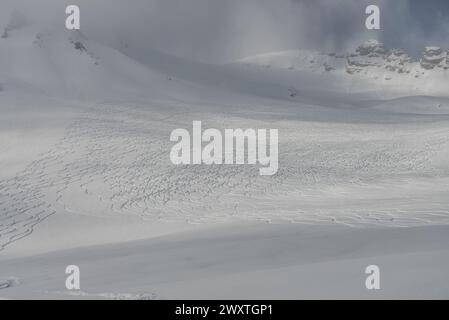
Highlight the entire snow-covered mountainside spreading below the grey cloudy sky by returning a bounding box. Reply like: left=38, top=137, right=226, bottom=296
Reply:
left=0, top=25, right=449, bottom=299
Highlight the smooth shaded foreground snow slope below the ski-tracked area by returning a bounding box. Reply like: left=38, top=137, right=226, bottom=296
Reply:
left=0, top=224, right=449, bottom=300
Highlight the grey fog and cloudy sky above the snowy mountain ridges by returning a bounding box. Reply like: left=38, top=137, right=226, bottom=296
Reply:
left=0, top=0, right=449, bottom=62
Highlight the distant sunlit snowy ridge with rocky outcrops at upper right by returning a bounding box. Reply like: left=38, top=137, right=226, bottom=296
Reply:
left=237, top=40, right=449, bottom=95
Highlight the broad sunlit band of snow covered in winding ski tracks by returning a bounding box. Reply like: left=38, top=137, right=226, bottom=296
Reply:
left=0, top=101, right=449, bottom=250
